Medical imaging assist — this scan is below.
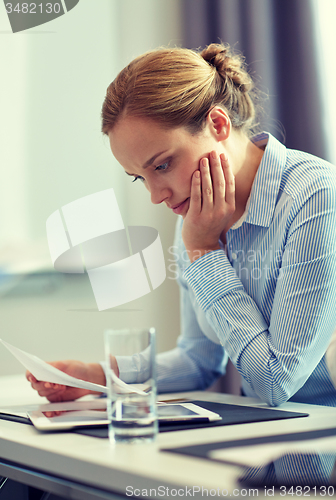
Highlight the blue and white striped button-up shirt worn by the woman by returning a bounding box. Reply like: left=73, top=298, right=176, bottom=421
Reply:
left=119, top=134, right=336, bottom=406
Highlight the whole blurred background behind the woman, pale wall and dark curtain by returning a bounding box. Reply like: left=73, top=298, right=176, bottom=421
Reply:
left=0, top=0, right=336, bottom=391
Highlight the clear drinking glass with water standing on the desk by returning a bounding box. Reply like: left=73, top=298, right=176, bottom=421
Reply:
left=104, top=328, right=158, bottom=443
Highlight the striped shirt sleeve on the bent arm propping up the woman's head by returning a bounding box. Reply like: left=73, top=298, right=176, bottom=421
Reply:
left=184, top=187, right=336, bottom=406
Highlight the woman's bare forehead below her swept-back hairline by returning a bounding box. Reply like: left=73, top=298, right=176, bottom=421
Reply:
left=109, top=116, right=187, bottom=172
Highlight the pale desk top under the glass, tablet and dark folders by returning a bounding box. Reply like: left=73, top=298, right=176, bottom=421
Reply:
left=0, top=376, right=336, bottom=500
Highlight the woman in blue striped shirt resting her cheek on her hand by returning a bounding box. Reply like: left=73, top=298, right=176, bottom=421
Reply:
left=27, top=44, right=336, bottom=406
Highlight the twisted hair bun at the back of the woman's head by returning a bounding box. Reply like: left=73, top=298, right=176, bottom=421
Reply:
left=200, top=43, right=253, bottom=92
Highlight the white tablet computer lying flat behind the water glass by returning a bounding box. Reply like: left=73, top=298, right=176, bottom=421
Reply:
left=27, top=399, right=221, bottom=431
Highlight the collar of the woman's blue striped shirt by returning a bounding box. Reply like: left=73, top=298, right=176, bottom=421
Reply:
left=242, top=132, right=287, bottom=227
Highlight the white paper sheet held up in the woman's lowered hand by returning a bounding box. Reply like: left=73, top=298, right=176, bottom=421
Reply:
left=0, top=339, right=146, bottom=395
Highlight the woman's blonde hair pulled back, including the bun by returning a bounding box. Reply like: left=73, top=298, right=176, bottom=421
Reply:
left=102, top=44, right=256, bottom=134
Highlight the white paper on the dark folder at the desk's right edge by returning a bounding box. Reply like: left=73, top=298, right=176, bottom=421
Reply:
left=209, top=437, right=336, bottom=467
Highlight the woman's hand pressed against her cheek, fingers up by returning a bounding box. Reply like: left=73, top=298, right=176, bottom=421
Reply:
left=182, top=151, right=235, bottom=262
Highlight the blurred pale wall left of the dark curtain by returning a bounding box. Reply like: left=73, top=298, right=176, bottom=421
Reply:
left=0, top=0, right=181, bottom=375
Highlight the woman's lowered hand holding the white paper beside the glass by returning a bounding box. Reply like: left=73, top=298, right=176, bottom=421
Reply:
left=26, top=360, right=106, bottom=403
